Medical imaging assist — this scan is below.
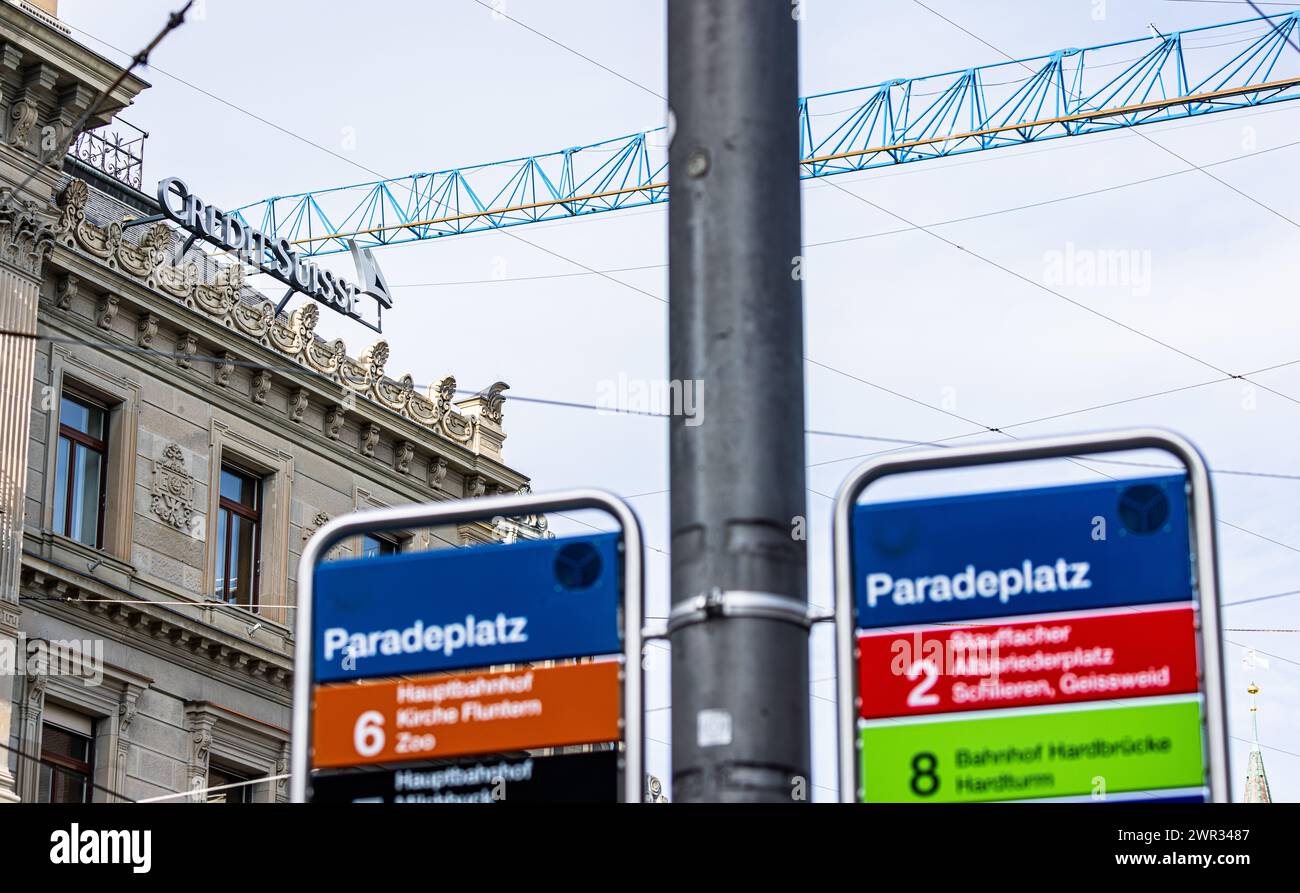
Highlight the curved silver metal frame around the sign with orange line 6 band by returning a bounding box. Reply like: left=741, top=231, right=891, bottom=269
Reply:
left=289, top=490, right=645, bottom=803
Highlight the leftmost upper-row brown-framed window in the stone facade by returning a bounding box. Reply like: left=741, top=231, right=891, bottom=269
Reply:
left=55, top=394, right=108, bottom=549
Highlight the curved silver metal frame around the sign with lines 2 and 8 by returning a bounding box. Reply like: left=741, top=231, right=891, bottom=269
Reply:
left=832, top=428, right=1230, bottom=803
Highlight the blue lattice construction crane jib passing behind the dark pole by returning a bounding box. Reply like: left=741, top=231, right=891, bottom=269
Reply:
left=234, top=10, right=1300, bottom=256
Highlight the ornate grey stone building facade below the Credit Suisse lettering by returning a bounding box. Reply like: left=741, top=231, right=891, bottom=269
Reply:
left=0, top=3, right=545, bottom=802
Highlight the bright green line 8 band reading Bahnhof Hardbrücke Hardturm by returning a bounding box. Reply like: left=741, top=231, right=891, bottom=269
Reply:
left=859, top=698, right=1205, bottom=803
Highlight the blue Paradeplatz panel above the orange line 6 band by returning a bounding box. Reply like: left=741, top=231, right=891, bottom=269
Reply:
left=313, top=533, right=623, bottom=682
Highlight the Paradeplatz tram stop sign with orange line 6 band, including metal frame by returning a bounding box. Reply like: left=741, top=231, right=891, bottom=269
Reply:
left=294, top=495, right=641, bottom=802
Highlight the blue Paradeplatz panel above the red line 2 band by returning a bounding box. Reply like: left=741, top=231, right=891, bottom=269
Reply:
left=853, top=474, right=1192, bottom=628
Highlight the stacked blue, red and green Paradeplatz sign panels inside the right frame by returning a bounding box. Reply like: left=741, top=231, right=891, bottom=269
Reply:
left=841, top=431, right=1223, bottom=802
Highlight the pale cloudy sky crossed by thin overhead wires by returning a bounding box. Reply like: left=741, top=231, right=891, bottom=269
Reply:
left=60, top=0, right=1300, bottom=801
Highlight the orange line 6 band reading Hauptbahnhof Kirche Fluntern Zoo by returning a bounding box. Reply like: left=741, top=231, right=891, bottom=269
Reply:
left=312, top=660, right=621, bottom=768
